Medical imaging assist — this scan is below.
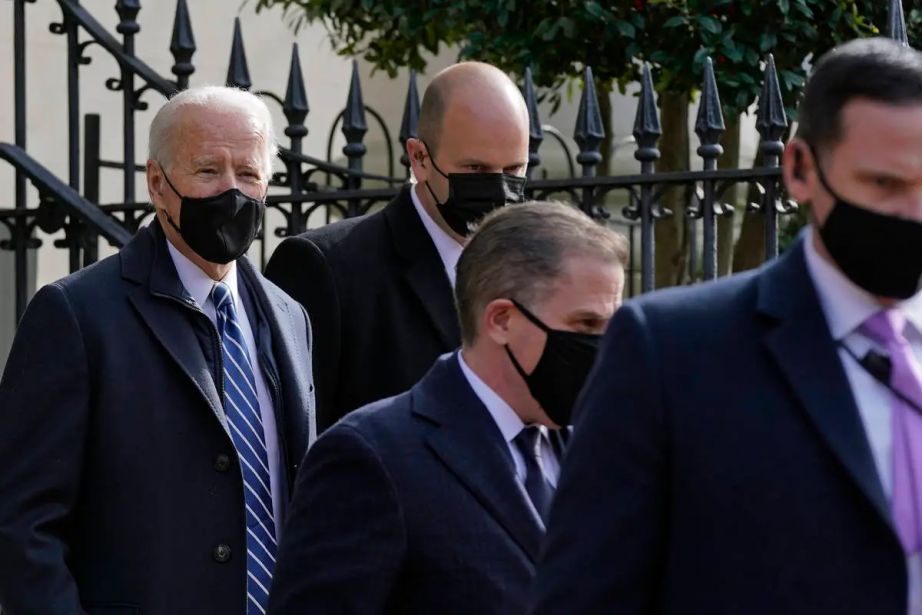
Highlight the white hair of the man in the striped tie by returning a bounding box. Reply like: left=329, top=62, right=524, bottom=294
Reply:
left=148, top=85, right=278, bottom=177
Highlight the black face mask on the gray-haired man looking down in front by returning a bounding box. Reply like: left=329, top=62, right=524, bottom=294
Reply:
left=506, top=299, right=602, bottom=427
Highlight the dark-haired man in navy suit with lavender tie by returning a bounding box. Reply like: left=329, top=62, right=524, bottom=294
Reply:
left=533, top=39, right=922, bottom=615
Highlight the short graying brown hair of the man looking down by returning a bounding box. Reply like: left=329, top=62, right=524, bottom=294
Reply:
left=455, top=201, right=628, bottom=346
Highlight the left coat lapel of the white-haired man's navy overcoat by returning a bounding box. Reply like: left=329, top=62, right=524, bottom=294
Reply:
left=120, top=222, right=228, bottom=431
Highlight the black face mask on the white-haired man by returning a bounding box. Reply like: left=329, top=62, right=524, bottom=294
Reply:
left=160, top=167, right=266, bottom=265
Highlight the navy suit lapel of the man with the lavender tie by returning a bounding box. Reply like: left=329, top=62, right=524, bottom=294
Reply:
left=759, top=240, right=891, bottom=525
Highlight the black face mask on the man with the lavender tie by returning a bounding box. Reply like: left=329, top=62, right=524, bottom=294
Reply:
left=813, top=152, right=922, bottom=299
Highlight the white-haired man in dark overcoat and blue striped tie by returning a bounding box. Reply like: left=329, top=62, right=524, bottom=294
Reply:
left=0, top=87, right=315, bottom=615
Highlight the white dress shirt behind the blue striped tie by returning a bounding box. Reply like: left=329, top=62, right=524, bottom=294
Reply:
left=167, top=240, right=283, bottom=538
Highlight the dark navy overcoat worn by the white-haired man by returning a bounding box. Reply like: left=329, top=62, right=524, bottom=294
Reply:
left=0, top=222, right=314, bottom=615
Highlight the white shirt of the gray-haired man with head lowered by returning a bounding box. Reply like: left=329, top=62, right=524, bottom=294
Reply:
left=458, top=350, right=560, bottom=489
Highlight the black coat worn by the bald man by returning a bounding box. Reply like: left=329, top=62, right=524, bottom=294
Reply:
left=266, top=186, right=461, bottom=430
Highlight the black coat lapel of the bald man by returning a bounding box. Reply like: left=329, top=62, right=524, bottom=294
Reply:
left=384, top=186, right=461, bottom=350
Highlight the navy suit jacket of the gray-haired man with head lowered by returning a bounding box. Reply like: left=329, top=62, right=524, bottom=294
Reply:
left=269, top=354, right=544, bottom=615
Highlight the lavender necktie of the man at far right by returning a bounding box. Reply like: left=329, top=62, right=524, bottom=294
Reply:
left=861, top=309, right=922, bottom=554
